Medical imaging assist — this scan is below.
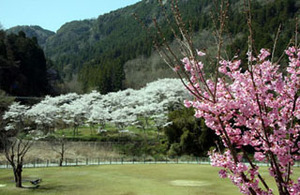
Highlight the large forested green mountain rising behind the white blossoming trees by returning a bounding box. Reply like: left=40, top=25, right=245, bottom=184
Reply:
left=5, top=0, right=300, bottom=93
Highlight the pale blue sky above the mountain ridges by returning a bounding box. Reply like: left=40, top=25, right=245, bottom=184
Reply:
left=0, top=0, right=141, bottom=32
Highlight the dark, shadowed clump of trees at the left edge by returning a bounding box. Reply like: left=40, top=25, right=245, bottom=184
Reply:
left=0, top=31, right=49, bottom=96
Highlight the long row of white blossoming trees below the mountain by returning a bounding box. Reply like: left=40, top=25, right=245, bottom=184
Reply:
left=6, top=79, right=188, bottom=135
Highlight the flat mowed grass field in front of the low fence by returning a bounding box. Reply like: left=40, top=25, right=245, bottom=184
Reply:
left=0, top=164, right=300, bottom=195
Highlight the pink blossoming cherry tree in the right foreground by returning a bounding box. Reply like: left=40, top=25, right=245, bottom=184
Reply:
left=182, top=47, right=300, bottom=194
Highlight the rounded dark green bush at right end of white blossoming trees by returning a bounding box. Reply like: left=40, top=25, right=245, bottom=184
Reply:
left=164, top=108, right=217, bottom=156
